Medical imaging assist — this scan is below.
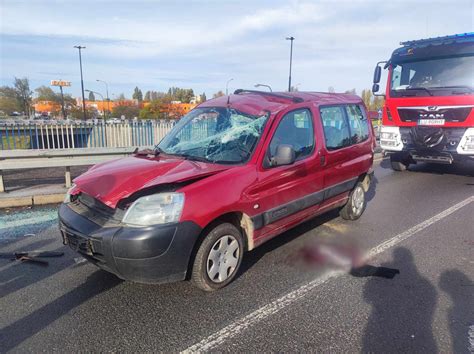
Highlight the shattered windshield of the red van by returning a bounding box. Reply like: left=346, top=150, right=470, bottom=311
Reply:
left=158, top=107, right=268, bottom=163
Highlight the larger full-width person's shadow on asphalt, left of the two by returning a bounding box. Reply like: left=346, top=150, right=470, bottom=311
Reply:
left=362, top=247, right=437, bottom=353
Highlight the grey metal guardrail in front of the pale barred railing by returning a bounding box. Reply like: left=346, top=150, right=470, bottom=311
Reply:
left=0, top=146, right=151, bottom=192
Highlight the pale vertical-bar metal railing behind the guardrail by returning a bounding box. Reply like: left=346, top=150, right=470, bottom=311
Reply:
left=0, top=120, right=176, bottom=150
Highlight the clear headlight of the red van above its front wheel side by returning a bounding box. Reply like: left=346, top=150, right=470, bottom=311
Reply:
left=122, top=193, right=184, bottom=226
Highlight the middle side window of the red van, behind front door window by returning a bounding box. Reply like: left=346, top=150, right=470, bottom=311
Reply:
left=320, top=106, right=350, bottom=150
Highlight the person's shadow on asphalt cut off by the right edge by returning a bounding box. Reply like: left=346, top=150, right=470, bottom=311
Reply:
left=439, top=269, right=474, bottom=353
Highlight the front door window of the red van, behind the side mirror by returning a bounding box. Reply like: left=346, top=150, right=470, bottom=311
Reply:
left=270, top=109, right=314, bottom=160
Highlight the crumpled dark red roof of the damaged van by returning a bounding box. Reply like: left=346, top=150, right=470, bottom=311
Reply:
left=199, top=90, right=362, bottom=115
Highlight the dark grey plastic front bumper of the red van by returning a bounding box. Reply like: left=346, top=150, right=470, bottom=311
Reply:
left=59, top=204, right=201, bottom=283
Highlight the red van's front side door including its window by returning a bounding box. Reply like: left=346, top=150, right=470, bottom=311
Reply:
left=253, top=108, right=323, bottom=245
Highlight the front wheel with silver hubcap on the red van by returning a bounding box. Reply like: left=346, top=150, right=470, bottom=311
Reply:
left=191, top=223, right=244, bottom=291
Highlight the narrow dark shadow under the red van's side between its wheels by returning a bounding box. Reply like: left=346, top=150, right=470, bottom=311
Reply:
left=236, top=209, right=339, bottom=279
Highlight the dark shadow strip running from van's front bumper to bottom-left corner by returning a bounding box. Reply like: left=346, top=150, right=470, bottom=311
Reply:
left=0, top=270, right=122, bottom=352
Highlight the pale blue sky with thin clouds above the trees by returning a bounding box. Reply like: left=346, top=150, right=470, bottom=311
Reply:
left=0, top=0, right=474, bottom=98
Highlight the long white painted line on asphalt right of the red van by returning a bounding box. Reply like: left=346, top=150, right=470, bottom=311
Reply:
left=183, top=195, right=474, bottom=352
